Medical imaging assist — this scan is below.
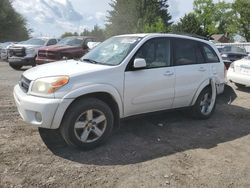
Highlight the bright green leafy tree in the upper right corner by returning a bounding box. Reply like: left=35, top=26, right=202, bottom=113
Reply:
left=233, top=0, right=250, bottom=41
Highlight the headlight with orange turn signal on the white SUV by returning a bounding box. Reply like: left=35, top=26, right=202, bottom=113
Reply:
left=31, top=76, right=69, bottom=95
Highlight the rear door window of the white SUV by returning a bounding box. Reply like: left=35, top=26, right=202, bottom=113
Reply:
left=174, top=39, right=197, bottom=65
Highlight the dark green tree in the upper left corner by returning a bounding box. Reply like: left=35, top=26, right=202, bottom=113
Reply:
left=0, top=0, right=29, bottom=42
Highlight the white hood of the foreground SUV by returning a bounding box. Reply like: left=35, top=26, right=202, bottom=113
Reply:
left=23, top=60, right=112, bottom=80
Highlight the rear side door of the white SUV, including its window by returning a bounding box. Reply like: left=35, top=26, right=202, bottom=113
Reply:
left=173, top=38, right=210, bottom=108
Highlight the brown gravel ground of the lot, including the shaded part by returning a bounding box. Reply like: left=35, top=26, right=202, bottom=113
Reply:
left=0, top=62, right=250, bottom=188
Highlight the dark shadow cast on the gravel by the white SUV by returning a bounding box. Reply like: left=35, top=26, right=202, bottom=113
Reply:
left=41, top=86, right=250, bottom=165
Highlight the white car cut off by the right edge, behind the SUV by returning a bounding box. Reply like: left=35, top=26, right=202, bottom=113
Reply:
left=227, top=56, right=250, bottom=88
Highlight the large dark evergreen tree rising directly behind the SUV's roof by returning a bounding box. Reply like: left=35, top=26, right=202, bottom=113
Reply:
left=106, top=0, right=172, bottom=36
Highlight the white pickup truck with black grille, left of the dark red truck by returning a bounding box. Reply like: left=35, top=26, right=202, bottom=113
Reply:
left=8, top=37, right=57, bottom=70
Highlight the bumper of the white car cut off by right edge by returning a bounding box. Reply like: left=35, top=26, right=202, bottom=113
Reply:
left=227, top=69, right=250, bottom=86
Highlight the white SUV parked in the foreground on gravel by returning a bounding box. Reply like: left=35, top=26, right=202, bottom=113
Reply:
left=14, top=34, right=224, bottom=149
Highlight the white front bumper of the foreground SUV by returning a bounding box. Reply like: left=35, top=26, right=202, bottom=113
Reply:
left=14, top=85, right=73, bottom=129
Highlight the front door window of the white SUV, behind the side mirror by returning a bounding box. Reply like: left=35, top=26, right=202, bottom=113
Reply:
left=135, top=38, right=170, bottom=68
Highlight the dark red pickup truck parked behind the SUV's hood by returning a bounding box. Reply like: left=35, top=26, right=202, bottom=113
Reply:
left=36, top=36, right=95, bottom=65
